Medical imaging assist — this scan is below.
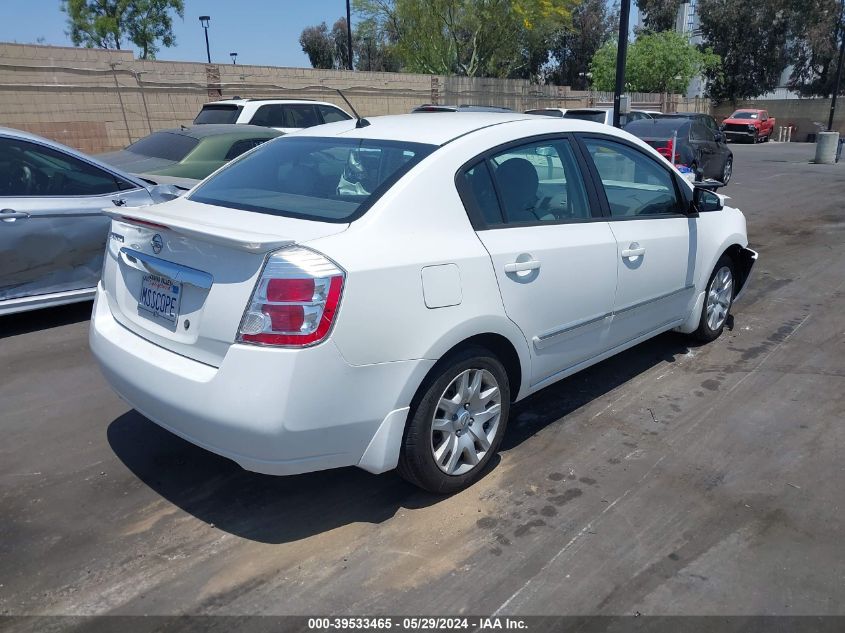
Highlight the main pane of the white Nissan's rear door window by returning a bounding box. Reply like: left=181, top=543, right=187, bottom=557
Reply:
left=490, top=140, right=591, bottom=224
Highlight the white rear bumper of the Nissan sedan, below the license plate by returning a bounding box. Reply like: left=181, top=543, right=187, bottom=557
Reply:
left=89, top=292, right=433, bottom=475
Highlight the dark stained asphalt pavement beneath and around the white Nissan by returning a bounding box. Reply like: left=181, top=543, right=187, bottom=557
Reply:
left=0, top=143, right=845, bottom=615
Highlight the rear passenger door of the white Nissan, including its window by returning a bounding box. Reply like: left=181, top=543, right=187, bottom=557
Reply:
left=458, top=138, right=616, bottom=386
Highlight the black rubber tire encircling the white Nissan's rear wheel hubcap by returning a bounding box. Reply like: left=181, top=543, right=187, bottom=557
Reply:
left=397, top=346, right=510, bottom=494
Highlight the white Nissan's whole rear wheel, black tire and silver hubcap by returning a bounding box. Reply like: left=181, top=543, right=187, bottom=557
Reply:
left=398, top=347, right=510, bottom=494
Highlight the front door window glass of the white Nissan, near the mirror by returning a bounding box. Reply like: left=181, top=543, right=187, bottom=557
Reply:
left=584, top=138, right=683, bottom=218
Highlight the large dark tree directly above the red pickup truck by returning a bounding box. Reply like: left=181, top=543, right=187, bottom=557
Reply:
left=698, top=0, right=792, bottom=104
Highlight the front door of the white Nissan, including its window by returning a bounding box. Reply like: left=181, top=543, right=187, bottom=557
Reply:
left=579, top=135, right=697, bottom=347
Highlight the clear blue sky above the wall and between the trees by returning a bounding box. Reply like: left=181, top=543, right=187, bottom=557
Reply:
left=0, top=0, right=637, bottom=68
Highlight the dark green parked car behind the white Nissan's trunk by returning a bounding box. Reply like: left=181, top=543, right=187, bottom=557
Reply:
left=98, top=125, right=281, bottom=181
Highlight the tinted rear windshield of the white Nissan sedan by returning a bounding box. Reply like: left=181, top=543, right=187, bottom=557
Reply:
left=190, top=136, right=436, bottom=222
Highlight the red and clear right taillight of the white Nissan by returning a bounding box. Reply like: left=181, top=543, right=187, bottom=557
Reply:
left=238, top=246, right=345, bottom=347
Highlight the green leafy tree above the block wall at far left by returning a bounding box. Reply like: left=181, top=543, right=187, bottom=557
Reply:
left=62, top=0, right=185, bottom=59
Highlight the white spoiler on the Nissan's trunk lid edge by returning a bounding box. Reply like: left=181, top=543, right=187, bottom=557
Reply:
left=103, top=207, right=296, bottom=253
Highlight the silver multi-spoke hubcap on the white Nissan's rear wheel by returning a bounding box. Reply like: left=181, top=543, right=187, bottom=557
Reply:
left=430, top=369, right=502, bottom=475
